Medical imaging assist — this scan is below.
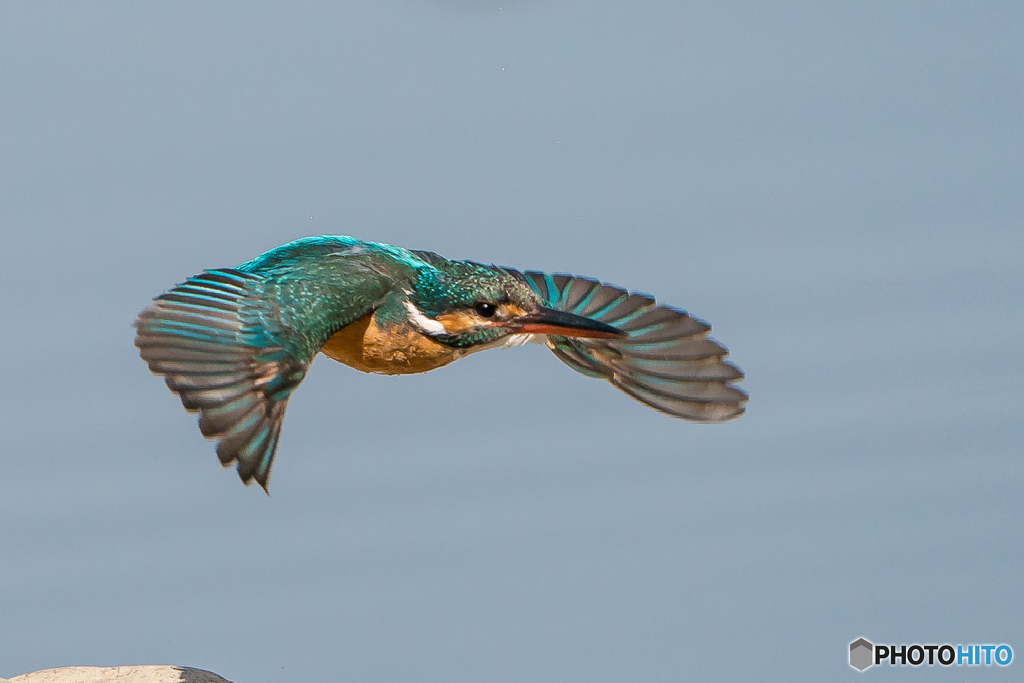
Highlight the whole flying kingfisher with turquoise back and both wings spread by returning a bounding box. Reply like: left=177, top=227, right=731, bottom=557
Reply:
left=135, top=236, right=746, bottom=490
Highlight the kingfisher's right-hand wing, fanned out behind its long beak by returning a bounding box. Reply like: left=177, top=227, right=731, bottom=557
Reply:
left=524, top=271, right=746, bottom=422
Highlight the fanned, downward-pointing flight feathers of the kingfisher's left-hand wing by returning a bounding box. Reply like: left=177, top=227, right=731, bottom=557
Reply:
left=135, top=268, right=308, bottom=489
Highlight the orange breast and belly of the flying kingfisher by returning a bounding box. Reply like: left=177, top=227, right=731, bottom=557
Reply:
left=321, top=313, right=464, bottom=375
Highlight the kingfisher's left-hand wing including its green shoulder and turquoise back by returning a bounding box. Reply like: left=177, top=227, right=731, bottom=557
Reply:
left=135, top=236, right=401, bottom=489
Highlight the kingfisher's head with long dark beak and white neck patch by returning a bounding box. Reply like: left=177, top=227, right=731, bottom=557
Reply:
left=406, top=259, right=628, bottom=348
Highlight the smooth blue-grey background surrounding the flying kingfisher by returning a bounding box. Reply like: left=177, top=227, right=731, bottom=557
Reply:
left=0, top=0, right=1024, bottom=683
